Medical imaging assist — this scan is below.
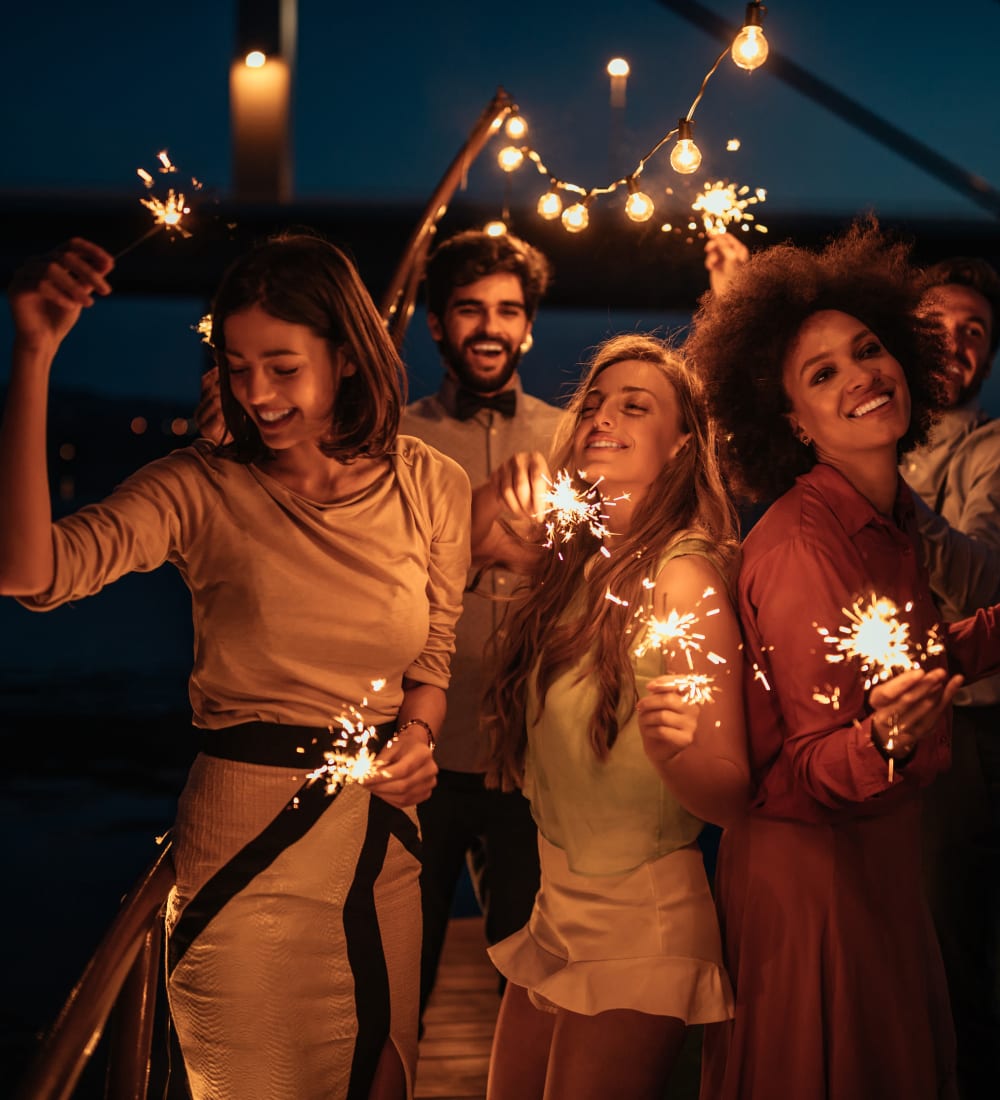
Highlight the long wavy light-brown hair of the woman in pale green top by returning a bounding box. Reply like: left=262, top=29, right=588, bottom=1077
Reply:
left=484, top=334, right=737, bottom=790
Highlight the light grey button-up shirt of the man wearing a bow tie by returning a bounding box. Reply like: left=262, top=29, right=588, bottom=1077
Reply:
left=399, top=376, right=563, bottom=772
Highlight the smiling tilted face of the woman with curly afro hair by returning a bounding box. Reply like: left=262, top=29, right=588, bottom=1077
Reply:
left=782, top=309, right=910, bottom=472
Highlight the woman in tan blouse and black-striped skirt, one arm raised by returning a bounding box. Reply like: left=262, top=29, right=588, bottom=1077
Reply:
left=0, top=237, right=470, bottom=1100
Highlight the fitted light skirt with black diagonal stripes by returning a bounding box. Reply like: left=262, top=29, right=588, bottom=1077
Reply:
left=167, top=755, right=420, bottom=1100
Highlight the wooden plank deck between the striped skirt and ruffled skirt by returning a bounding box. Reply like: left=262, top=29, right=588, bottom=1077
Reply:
left=415, top=916, right=499, bottom=1100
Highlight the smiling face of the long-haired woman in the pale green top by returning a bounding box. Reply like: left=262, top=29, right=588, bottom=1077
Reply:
left=573, top=359, right=689, bottom=505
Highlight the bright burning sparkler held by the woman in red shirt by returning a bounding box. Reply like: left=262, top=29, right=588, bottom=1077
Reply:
left=813, top=593, right=944, bottom=783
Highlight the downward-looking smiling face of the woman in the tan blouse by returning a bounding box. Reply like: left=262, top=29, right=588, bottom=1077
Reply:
left=224, top=306, right=354, bottom=451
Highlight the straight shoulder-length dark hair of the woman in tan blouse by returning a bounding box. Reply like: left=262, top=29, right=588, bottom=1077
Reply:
left=211, top=233, right=406, bottom=462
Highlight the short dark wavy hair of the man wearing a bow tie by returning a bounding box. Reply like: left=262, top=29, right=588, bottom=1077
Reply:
left=425, top=229, right=552, bottom=321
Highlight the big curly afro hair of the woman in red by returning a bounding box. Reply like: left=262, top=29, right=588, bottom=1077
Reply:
left=684, top=219, right=945, bottom=501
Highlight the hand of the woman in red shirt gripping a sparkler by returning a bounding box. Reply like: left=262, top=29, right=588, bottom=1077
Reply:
left=868, top=669, right=963, bottom=760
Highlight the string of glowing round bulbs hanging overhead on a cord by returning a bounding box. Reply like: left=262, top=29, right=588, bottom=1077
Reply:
left=488, top=0, right=767, bottom=233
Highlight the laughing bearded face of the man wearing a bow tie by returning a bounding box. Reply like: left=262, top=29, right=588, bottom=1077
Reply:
left=427, top=272, right=531, bottom=394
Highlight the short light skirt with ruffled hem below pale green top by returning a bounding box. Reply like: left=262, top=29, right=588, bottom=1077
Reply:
left=490, top=835, right=733, bottom=1024
